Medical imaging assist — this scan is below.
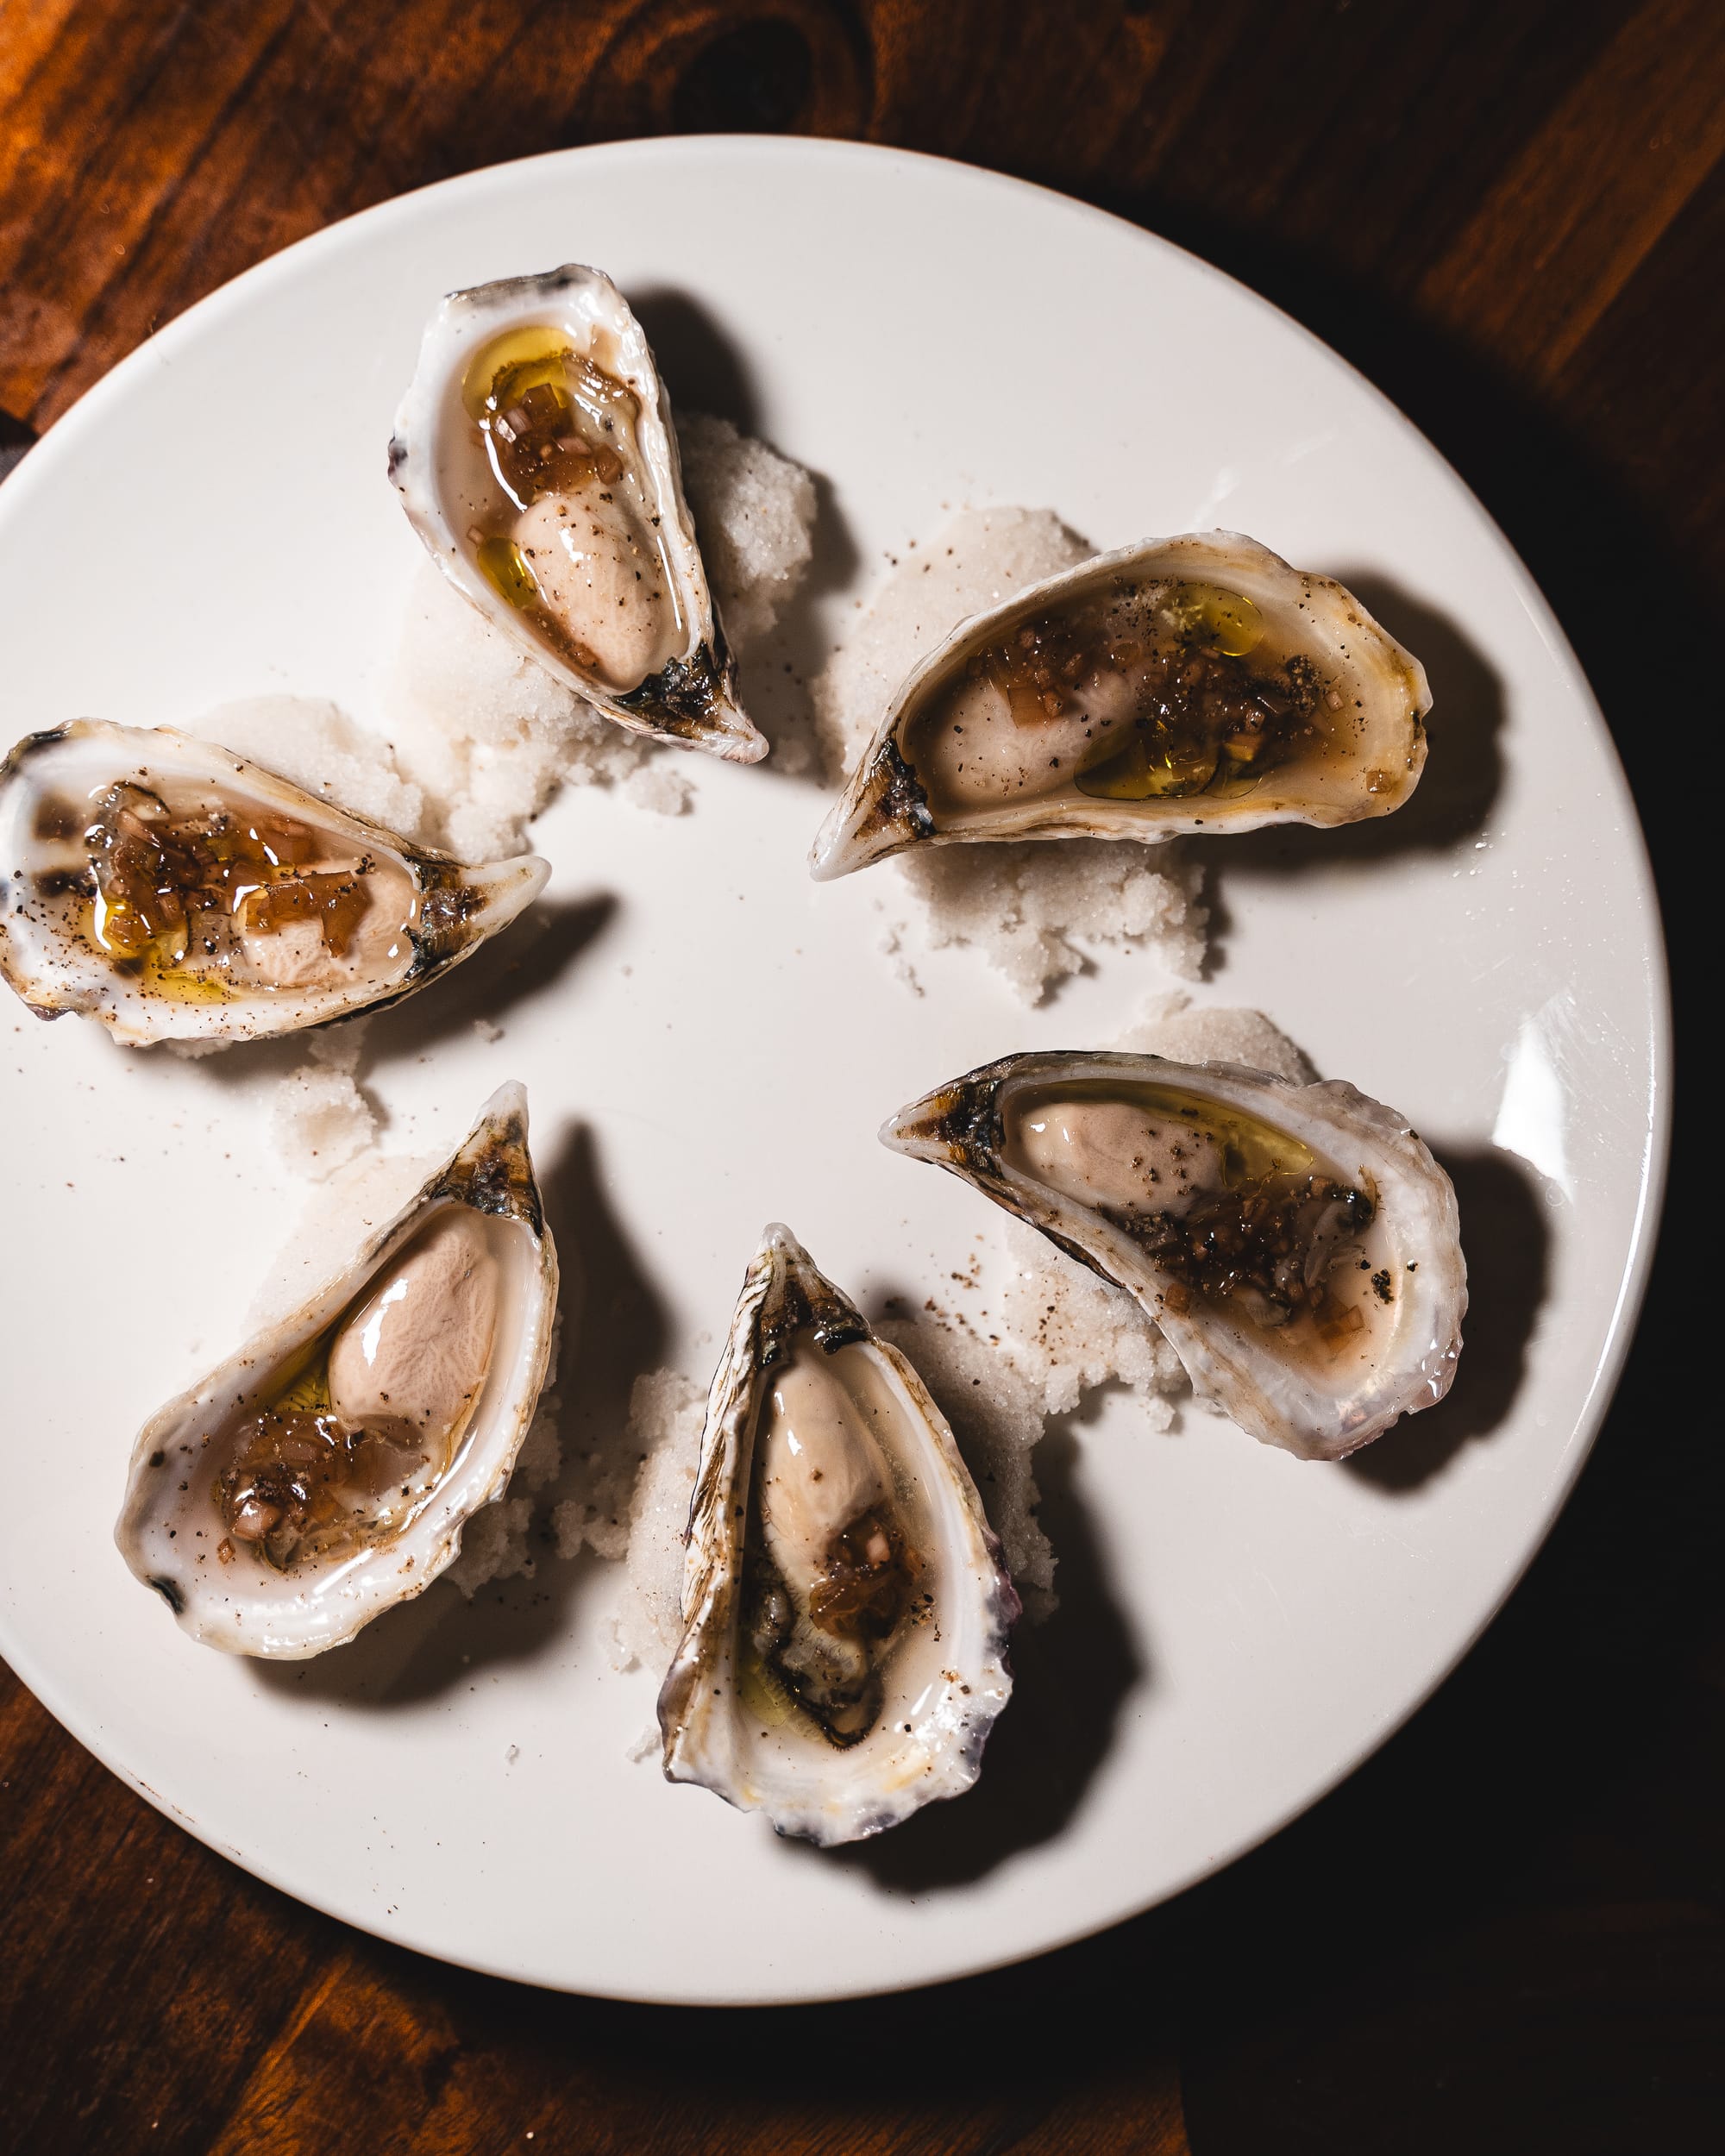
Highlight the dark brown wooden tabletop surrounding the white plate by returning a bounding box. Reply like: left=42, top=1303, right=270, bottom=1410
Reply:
left=0, top=0, right=1725, bottom=2156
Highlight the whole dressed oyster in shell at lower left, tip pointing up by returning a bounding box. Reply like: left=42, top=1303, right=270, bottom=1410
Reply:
left=115, top=1085, right=556, bottom=1660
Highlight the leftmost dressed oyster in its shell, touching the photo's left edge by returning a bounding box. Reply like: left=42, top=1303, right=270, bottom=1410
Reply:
left=0, top=718, right=550, bottom=1046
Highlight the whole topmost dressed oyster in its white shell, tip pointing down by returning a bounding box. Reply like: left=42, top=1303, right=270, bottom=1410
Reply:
left=391, top=263, right=768, bottom=763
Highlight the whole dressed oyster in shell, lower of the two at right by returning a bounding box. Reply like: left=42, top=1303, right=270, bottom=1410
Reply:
left=880, top=1052, right=1469, bottom=1460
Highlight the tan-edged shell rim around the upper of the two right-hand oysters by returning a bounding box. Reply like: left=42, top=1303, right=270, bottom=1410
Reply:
left=811, top=533, right=1432, bottom=882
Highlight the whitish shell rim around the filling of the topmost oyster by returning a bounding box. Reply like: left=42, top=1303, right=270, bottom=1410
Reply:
left=391, top=263, right=768, bottom=763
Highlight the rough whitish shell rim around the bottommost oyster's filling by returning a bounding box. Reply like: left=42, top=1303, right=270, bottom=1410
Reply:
left=660, top=1227, right=1018, bottom=1846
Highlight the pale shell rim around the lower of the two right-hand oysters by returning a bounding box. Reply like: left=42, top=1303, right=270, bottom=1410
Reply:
left=880, top=1050, right=1469, bottom=1460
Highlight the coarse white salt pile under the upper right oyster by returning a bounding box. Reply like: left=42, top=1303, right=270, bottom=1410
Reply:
left=813, top=509, right=1206, bottom=1003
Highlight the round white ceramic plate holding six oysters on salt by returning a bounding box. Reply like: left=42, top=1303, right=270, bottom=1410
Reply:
left=0, top=141, right=1665, bottom=2001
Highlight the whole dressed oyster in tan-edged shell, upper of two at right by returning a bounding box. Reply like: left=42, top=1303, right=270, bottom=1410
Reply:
left=811, top=533, right=1432, bottom=882
